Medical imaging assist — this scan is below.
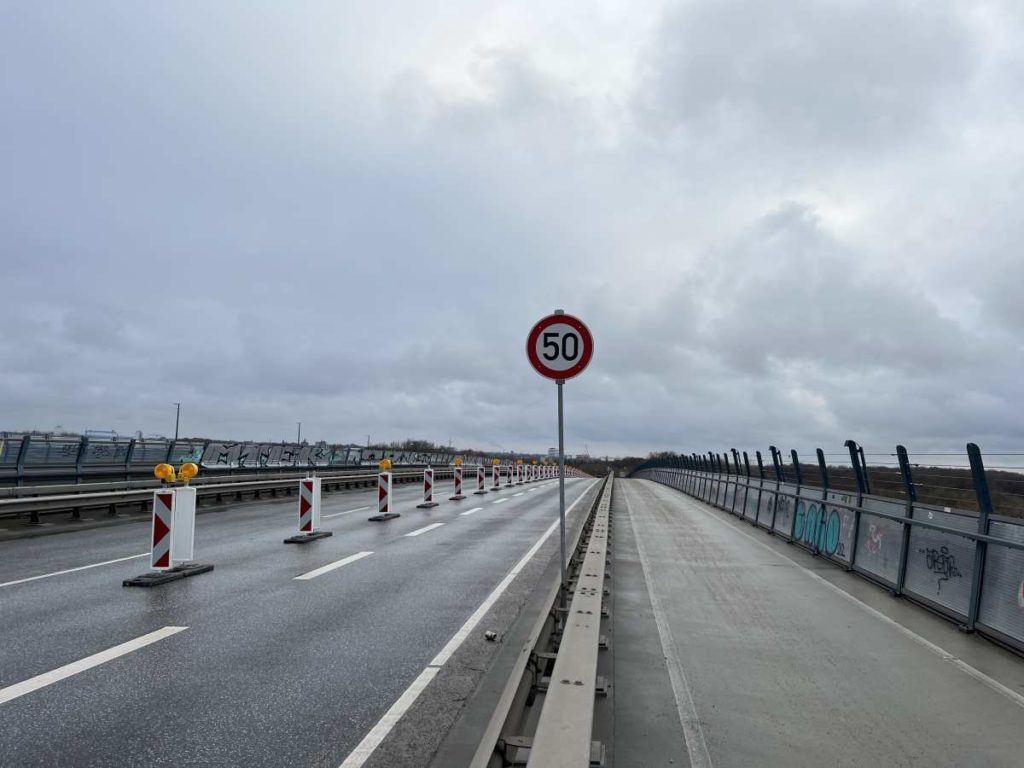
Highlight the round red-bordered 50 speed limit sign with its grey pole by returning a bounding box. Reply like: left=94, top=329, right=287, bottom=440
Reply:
left=526, top=309, right=594, bottom=608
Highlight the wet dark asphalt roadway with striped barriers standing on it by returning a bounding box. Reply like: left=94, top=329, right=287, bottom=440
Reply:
left=0, top=481, right=590, bottom=768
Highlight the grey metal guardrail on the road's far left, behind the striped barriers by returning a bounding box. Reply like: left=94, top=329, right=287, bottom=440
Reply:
left=0, top=469, right=453, bottom=524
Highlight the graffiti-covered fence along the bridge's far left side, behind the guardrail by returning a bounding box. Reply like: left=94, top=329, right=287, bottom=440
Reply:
left=0, top=433, right=532, bottom=485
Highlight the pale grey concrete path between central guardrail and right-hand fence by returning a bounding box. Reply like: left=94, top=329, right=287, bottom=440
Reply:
left=613, top=480, right=1024, bottom=768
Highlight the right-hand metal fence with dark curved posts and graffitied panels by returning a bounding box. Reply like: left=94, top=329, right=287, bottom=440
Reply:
left=631, top=441, right=1024, bottom=652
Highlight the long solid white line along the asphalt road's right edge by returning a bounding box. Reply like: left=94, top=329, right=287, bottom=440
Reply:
left=339, top=480, right=596, bottom=768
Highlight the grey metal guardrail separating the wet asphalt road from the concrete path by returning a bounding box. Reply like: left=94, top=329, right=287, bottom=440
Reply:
left=469, top=475, right=612, bottom=768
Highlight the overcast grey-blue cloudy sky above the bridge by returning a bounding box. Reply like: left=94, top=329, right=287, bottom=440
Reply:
left=0, top=0, right=1024, bottom=454
